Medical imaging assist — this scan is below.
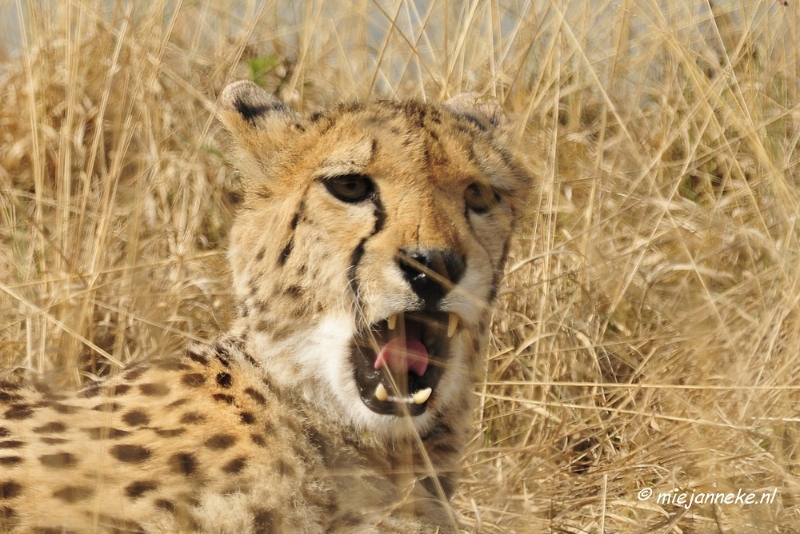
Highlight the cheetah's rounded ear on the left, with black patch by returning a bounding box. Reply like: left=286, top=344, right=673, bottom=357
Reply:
left=217, top=80, right=303, bottom=189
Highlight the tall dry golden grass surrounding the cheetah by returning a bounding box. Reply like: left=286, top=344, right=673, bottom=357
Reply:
left=0, top=0, right=800, bottom=533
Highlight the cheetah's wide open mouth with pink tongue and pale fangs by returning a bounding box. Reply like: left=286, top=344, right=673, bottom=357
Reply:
left=351, top=312, right=458, bottom=416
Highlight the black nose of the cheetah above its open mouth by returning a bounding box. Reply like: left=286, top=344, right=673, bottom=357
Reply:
left=398, top=249, right=466, bottom=308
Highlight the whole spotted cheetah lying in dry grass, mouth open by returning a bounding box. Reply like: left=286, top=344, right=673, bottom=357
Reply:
left=0, top=81, right=532, bottom=534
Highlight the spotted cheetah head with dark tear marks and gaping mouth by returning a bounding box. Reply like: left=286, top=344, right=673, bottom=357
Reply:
left=219, top=82, right=530, bottom=433
